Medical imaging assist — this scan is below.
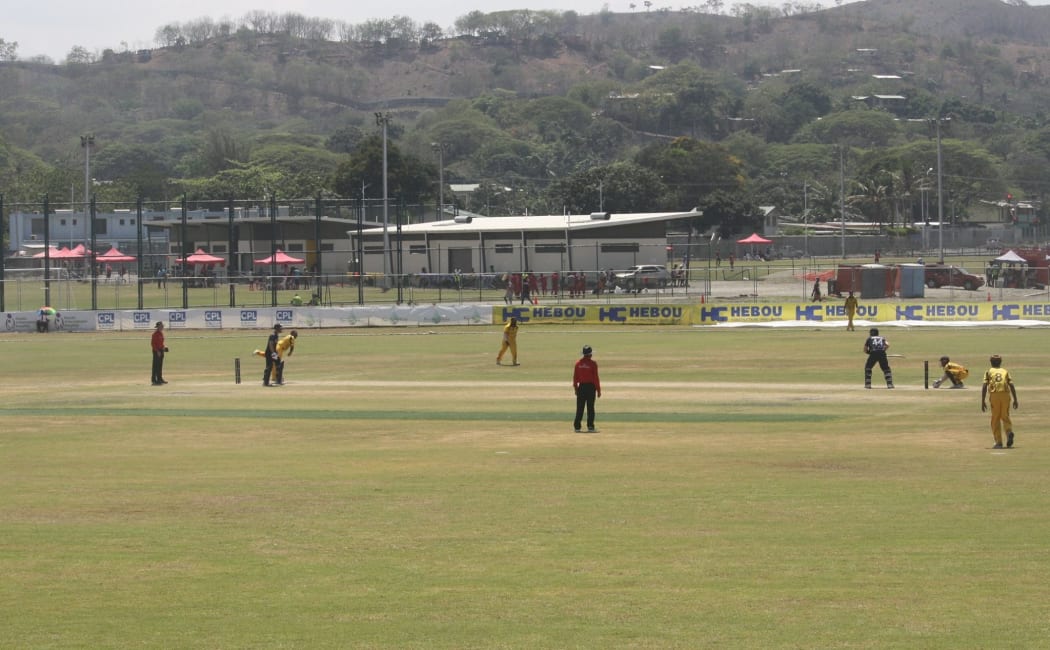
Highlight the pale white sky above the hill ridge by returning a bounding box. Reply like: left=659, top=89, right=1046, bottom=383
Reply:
left=12, top=0, right=1050, bottom=63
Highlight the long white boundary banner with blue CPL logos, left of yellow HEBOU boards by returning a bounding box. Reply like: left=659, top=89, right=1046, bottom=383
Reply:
left=2, top=305, right=492, bottom=332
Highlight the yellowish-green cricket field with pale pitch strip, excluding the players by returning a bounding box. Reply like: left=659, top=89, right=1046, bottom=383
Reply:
left=0, top=327, right=1050, bottom=650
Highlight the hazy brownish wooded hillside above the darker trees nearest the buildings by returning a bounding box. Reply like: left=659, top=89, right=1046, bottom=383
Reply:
left=0, top=0, right=1050, bottom=223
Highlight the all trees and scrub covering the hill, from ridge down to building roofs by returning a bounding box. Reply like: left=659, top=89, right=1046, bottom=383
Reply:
left=0, top=0, right=1050, bottom=232
